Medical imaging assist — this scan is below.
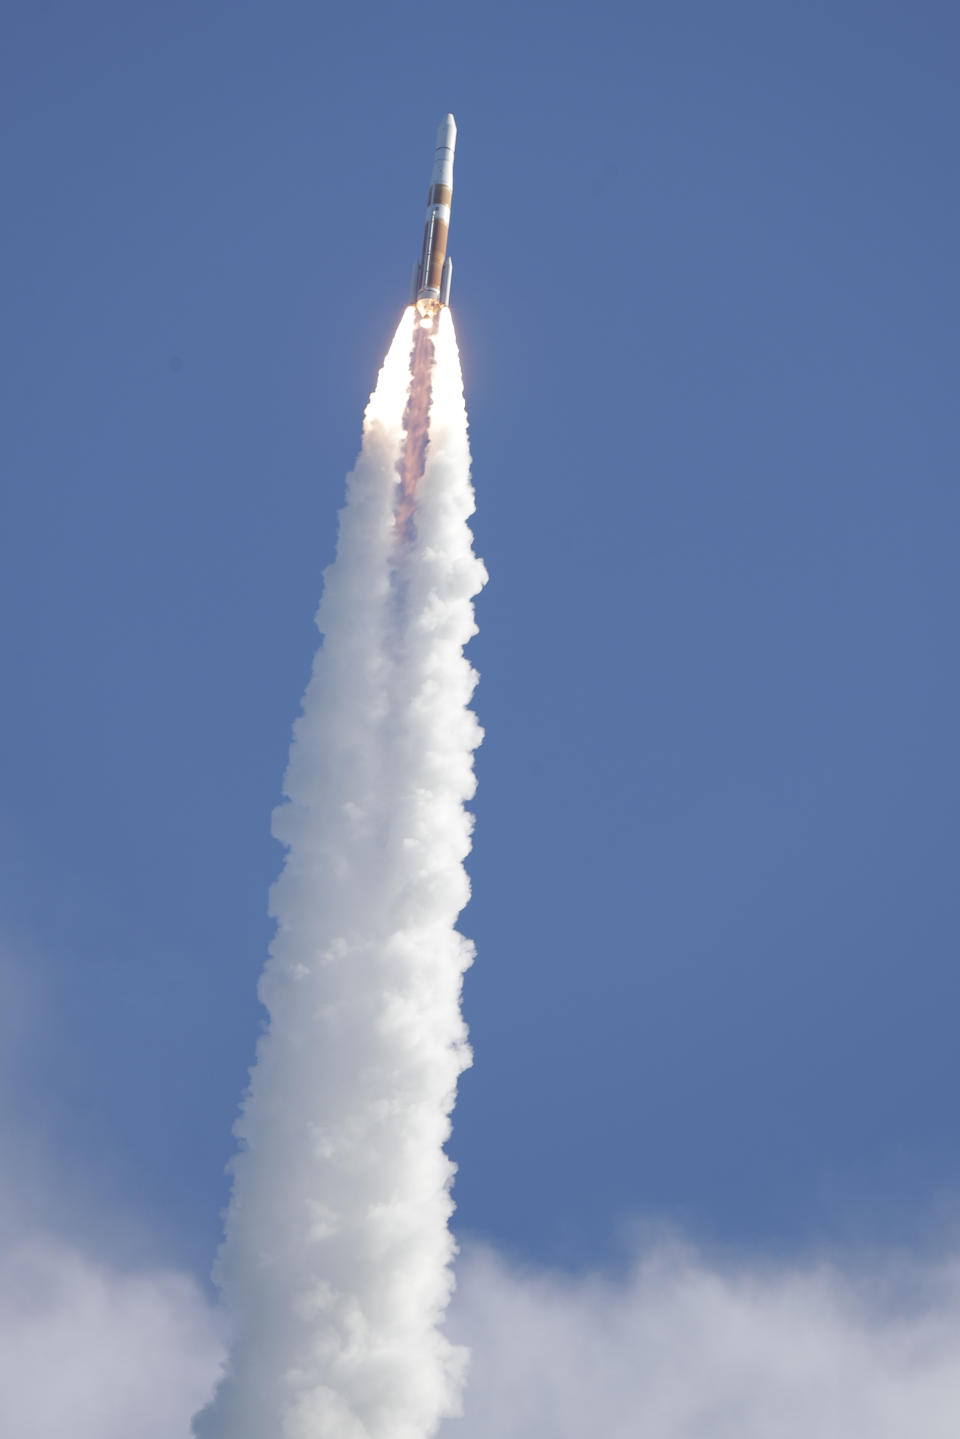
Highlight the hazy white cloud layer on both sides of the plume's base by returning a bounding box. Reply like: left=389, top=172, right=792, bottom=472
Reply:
left=0, top=1233, right=960, bottom=1439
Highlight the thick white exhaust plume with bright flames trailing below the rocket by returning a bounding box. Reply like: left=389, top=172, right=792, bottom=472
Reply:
left=194, top=308, right=486, bottom=1439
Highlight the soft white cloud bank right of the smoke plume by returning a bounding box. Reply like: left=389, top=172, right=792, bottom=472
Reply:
left=445, top=1242, right=960, bottom=1439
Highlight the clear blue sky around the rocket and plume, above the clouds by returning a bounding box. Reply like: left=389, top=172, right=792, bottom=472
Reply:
left=0, top=0, right=960, bottom=1318
